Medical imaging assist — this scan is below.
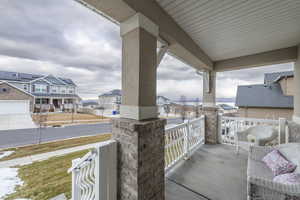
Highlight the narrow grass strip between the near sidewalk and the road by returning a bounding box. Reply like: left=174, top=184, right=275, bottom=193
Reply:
left=0, top=134, right=111, bottom=161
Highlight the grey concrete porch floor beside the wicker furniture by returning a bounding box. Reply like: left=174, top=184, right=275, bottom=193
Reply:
left=166, top=144, right=247, bottom=200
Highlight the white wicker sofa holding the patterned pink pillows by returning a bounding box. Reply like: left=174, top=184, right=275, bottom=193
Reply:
left=247, top=143, right=300, bottom=200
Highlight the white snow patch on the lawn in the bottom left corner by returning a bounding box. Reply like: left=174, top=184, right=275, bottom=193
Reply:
left=0, top=168, right=23, bottom=200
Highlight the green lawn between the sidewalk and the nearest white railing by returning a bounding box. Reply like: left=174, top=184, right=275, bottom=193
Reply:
left=5, top=150, right=88, bottom=200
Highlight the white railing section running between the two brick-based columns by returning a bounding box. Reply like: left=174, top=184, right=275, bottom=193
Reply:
left=165, top=116, right=205, bottom=171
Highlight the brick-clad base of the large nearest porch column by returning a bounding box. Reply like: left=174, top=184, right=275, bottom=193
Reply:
left=112, top=118, right=166, bottom=200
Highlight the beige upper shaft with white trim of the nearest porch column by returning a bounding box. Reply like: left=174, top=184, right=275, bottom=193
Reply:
left=121, top=14, right=158, bottom=120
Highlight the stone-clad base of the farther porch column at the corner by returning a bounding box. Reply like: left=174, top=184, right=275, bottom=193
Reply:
left=202, top=107, right=219, bottom=144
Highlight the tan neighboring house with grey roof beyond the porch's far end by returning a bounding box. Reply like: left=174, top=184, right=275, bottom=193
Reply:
left=236, top=71, right=294, bottom=119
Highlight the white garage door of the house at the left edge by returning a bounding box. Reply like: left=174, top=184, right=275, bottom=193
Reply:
left=0, top=100, right=30, bottom=115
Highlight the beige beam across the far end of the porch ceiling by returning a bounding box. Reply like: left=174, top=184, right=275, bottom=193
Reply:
left=214, top=46, right=298, bottom=72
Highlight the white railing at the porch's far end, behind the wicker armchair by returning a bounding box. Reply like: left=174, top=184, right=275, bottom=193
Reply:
left=219, top=115, right=280, bottom=144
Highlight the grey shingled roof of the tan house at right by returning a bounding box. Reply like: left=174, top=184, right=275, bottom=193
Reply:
left=236, top=83, right=294, bottom=108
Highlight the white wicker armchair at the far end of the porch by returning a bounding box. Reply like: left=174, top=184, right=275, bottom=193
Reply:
left=234, top=125, right=278, bottom=154
